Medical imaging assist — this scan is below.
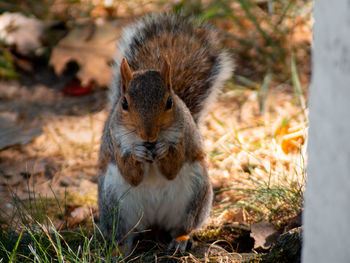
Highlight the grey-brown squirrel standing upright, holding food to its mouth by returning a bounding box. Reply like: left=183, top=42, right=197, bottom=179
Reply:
left=98, top=13, right=234, bottom=253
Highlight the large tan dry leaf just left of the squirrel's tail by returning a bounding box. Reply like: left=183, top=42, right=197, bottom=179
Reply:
left=50, top=22, right=119, bottom=86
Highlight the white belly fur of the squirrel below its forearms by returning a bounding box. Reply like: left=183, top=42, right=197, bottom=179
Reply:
left=103, top=163, right=202, bottom=230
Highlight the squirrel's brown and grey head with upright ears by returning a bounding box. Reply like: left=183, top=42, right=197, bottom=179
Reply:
left=118, top=57, right=174, bottom=142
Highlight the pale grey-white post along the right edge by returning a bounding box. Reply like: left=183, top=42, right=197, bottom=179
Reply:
left=302, top=0, right=350, bottom=263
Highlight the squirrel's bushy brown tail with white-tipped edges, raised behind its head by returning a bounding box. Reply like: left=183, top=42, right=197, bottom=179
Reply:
left=110, top=13, right=234, bottom=122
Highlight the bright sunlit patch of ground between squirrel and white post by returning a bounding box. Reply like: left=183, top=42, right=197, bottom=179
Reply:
left=202, top=89, right=307, bottom=229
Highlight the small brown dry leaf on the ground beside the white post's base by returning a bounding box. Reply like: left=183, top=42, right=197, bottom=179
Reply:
left=250, top=222, right=279, bottom=249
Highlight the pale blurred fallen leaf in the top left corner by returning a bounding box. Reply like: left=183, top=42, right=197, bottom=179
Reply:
left=0, top=12, right=44, bottom=55
